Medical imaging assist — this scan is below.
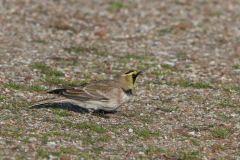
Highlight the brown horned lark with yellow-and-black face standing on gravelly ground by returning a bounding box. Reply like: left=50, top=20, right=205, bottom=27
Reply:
left=32, top=70, right=142, bottom=111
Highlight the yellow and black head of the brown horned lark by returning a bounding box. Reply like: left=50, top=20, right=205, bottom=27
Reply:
left=114, top=70, right=143, bottom=90
